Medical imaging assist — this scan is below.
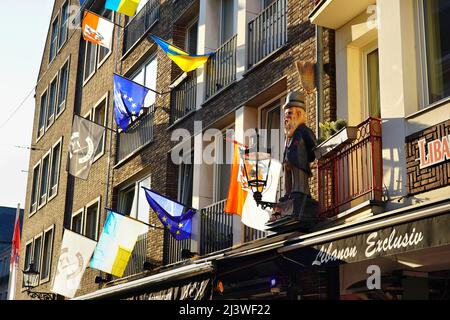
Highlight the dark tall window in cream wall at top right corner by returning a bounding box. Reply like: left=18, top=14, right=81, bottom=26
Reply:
left=423, top=0, right=450, bottom=104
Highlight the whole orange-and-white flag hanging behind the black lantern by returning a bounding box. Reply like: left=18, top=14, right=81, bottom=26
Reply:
left=225, top=143, right=281, bottom=231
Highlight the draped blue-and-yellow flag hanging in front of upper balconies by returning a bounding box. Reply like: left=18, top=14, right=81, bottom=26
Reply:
left=150, top=35, right=213, bottom=72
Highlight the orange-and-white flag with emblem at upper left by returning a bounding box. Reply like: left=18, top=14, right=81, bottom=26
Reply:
left=82, top=11, right=114, bottom=50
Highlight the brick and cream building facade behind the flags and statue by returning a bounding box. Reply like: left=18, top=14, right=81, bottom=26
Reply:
left=18, top=0, right=450, bottom=299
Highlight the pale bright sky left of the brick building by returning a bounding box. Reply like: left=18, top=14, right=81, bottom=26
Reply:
left=0, top=0, right=54, bottom=208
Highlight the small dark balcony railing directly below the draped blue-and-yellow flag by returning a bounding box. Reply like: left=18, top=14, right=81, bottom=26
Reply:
left=170, top=72, right=197, bottom=123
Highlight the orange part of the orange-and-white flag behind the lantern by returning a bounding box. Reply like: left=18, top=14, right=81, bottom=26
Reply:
left=225, top=143, right=247, bottom=215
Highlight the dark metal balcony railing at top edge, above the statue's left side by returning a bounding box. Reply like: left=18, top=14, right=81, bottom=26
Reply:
left=248, top=0, right=288, bottom=68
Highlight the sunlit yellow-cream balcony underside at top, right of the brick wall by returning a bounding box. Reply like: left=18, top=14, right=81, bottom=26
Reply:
left=309, top=0, right=376, bottom=30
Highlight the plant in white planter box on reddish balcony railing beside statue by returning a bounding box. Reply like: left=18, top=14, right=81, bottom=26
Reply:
left=314, top=119, right=358, bottom=159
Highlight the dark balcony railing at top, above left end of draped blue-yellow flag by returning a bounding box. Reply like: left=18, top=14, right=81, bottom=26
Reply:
left=123, top=0, right=160, bottom=55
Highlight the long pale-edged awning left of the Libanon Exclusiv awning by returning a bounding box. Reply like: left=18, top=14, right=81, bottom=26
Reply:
left=73, top=262, right=214, bottom=300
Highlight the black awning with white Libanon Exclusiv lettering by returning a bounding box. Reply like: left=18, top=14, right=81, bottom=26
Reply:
left=278, top=201, right=450, bottom=267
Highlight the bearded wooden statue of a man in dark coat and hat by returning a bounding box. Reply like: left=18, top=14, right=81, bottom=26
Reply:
left=279, top=91, right=317, bottom=217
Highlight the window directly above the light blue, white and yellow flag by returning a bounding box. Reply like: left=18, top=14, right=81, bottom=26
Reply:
left=118, top=177, right=151, bottom=228
